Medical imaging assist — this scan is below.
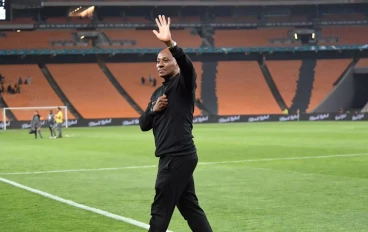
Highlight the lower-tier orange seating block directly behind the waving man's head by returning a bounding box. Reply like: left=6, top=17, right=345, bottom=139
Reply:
left=106, top=62, right=202, bottom=116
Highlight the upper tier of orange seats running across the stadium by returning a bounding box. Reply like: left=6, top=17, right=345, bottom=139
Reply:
left=0, top=26, right=368, bottom=49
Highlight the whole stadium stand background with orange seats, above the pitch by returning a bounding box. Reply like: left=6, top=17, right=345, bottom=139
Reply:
left=0, top=0, right=368, bottom=128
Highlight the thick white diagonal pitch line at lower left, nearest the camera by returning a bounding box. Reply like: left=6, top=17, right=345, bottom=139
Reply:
left=0, top=177, right=172, bottom=232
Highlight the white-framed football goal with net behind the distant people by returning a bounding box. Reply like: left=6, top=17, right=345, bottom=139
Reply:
left=2, top=106, right=69, bottom=130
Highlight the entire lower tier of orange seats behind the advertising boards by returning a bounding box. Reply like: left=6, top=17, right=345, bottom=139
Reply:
left=0, top=59, right=362, bottom=120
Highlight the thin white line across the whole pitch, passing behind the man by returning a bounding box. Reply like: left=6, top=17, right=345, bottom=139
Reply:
left=0, top=154, right=368, bottom=175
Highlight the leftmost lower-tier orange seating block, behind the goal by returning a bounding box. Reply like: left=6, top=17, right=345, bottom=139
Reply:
left=0, top=65, right=74, bottom=120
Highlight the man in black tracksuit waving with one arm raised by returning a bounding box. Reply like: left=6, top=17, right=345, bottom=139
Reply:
left=139, top=15, right=212, bottom=232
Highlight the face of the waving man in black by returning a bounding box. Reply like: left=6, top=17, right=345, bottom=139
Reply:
left=156, top=49, right=178, bottom=78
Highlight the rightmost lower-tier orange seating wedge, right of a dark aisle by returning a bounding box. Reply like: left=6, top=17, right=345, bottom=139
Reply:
left=307, top=59, right=351, bottom=112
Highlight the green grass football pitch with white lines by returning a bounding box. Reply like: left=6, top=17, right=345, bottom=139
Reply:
left=0, top=122, right=368, bottom=232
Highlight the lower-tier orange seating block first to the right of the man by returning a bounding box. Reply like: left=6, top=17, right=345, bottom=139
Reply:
left=217, top=61, right=281, bottom=115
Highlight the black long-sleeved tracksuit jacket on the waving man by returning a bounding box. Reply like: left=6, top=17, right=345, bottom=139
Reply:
left=139, top=46, right=197, bottom=157
